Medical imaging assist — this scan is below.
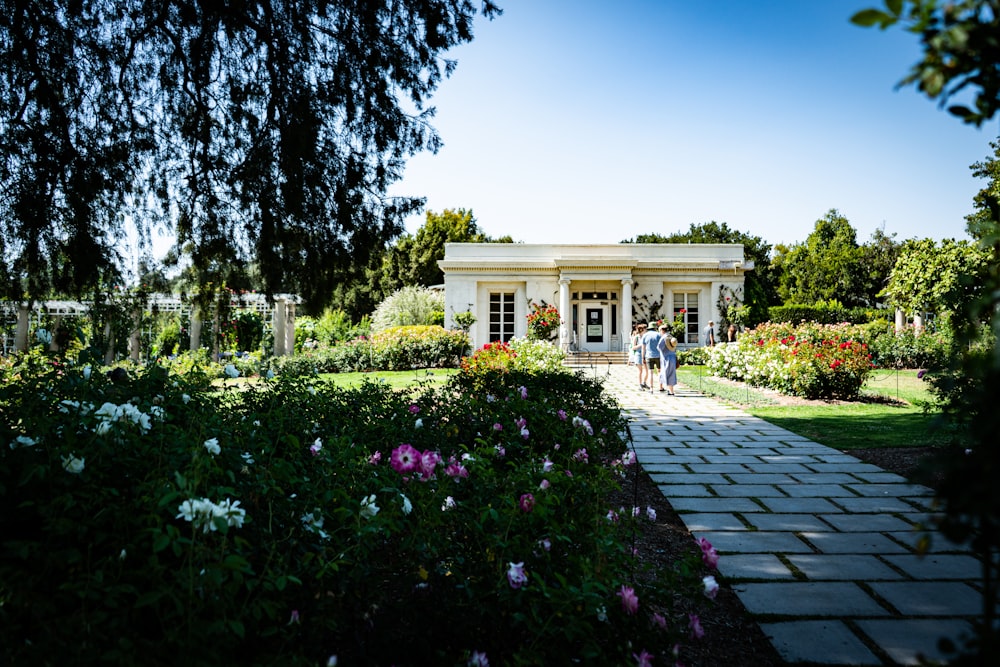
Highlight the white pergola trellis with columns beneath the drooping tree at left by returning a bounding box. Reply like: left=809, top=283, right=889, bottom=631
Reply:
left=0, top=292, right=301, bottom=363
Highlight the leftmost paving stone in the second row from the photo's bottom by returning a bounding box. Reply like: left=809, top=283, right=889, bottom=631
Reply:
left=733, top=581, right=889, bottom=617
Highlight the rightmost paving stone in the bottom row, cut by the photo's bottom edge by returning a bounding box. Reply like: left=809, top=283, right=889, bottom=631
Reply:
left=855, top=619, right=972, bottom=665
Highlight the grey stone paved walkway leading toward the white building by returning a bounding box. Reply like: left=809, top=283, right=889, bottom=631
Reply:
left=587, top=366, right=981, bottom=665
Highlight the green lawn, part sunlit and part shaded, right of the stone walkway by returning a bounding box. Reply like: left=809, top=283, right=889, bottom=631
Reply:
left=678, top=366, right=954, bottom=449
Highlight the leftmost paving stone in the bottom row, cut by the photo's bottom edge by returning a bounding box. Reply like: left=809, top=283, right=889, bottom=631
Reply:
left=760, top=620, right=882, bottom=665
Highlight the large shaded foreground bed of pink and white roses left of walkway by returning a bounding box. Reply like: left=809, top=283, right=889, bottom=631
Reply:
left=0, top=352, right=715, bottom=665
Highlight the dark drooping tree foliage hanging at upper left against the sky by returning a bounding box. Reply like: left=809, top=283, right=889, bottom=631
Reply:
left=0, top=0, right=500, bottom=306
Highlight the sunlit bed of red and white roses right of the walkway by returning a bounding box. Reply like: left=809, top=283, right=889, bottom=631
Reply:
left=708, top=323, right=873, bottom=400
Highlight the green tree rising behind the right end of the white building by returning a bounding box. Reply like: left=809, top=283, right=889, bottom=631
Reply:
left=622, top=220, right=776, bottom=324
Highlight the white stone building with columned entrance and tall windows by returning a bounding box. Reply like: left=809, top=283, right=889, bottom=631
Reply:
left=438, top=243, right=753, bottom=352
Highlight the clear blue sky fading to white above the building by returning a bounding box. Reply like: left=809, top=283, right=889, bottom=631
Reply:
left=391, top=0, right=997, bottom=244
